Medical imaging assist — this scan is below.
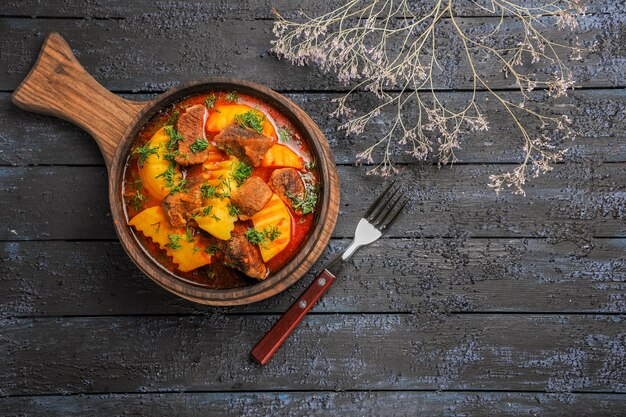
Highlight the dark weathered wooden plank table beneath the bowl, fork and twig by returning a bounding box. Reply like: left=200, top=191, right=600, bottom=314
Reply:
left=0, top=0, right=626, bottom=416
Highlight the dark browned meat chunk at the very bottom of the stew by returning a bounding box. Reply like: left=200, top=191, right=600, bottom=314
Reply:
left=224, top=223, right=267, bottom=279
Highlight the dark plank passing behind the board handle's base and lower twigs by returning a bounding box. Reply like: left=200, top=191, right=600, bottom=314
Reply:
left=0, top=89, right=626, bottom=166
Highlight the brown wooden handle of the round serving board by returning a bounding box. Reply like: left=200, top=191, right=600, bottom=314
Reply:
left=12, top=33, right=148, bottom=169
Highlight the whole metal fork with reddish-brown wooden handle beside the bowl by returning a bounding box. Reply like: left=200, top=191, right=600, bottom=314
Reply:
left=252, top=181, right=409, bottom=365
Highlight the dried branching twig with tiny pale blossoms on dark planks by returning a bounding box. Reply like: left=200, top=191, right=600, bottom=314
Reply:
left=273, top=0, right=584, bottom=194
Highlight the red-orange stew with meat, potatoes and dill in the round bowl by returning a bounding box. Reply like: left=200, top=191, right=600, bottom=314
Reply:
left=122, top=91, right=319, bottom=288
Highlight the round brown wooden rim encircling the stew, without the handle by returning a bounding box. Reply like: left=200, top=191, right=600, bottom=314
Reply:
left=109, top=77, right=339, bottom=306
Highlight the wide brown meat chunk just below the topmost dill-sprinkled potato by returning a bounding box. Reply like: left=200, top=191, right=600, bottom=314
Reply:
left=214, top=123, right=274, bottom=167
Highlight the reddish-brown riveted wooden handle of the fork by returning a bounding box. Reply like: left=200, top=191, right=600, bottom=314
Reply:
left=252, top=269, right=335, bottom=365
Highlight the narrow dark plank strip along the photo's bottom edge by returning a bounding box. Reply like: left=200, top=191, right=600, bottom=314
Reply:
left=0, top=391, right=624, bottom=417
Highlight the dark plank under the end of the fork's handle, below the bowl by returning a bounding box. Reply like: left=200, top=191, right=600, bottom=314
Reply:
left=0, top=314, right=626, bottom=396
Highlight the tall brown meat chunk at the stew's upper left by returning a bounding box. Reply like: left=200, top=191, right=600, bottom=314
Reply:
left=175, top=104, right=209, bottom=165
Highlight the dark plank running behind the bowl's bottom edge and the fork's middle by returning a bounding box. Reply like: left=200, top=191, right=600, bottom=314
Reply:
left=0, top=238, right=626, bottom=318
